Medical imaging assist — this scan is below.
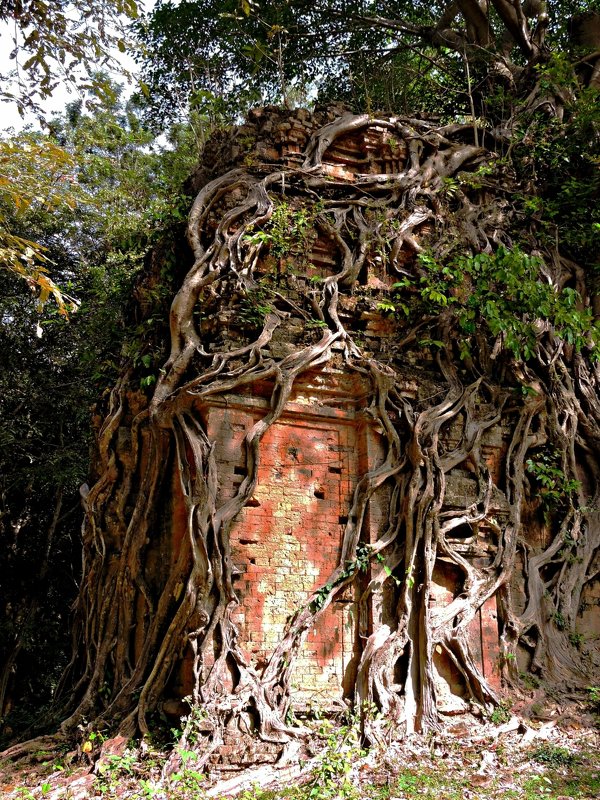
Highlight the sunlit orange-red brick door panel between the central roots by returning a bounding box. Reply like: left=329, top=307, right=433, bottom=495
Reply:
left=207, top=398, right=360, bottom=702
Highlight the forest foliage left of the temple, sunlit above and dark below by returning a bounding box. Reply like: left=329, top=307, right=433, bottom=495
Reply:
left=0, top=84, right=195, bottom=731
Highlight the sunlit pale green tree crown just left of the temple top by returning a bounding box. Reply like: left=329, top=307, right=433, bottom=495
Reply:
left=50, top=87, right=198, bottom=255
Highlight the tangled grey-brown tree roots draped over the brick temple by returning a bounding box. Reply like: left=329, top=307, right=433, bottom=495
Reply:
left=11, top=112, right=600, bottom=764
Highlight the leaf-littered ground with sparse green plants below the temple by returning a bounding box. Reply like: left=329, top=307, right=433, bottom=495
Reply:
left=0, top=709, right=600, bottom=800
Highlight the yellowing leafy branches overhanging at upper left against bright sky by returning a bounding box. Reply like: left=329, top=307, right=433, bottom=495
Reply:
left=0, top=0, right=144, bottom=315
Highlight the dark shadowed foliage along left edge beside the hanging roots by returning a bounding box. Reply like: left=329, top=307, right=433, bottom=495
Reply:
left=0, top=274, right=95, bottom=729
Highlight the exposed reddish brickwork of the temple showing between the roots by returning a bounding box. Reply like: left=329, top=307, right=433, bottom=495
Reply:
left=158, top=103, right=596, bottom=714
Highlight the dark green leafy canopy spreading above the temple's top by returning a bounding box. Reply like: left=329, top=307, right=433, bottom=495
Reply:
left=134, top=0, right=600, bottom=125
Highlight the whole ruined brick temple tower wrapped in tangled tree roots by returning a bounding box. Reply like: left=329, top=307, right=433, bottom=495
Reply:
left=1, top=3, right=600, bottom=758
